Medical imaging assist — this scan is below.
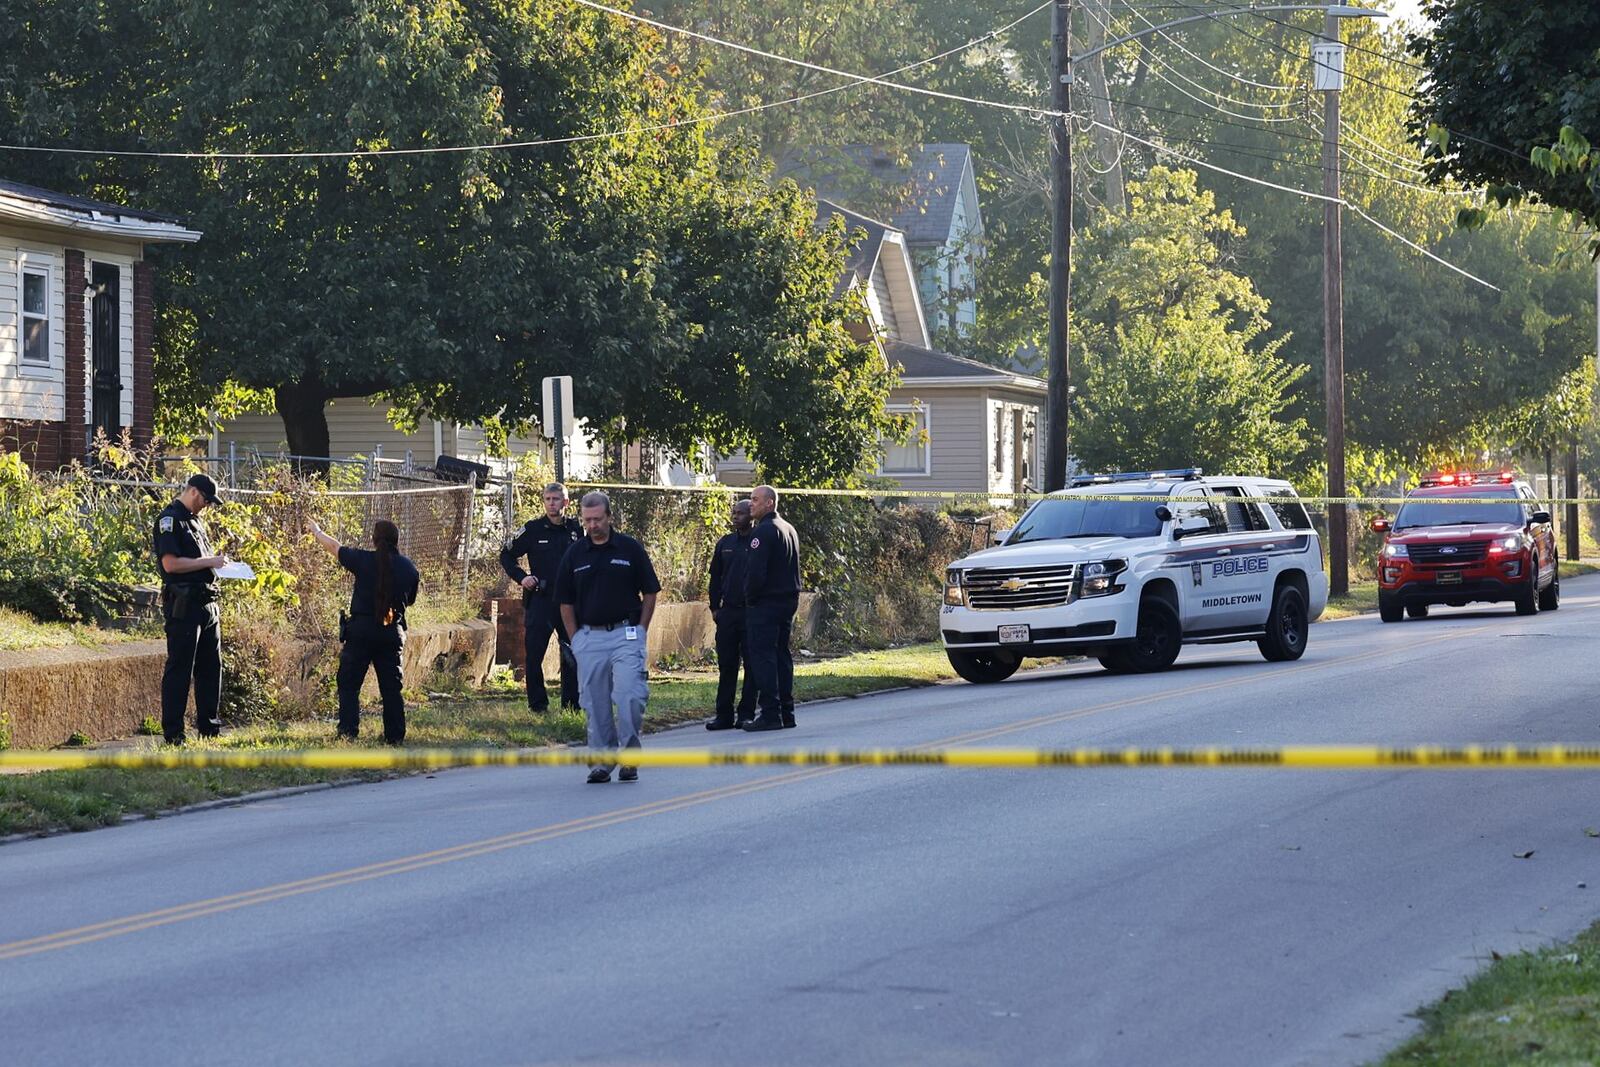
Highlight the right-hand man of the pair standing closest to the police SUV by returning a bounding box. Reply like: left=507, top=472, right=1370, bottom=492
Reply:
left=744, top=485, right=800, bottom=731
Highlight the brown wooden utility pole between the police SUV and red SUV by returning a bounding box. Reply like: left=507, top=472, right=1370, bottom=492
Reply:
left=1312, top=11, right=1350, bottom=597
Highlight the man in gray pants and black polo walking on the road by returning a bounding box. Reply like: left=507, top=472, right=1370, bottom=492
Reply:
left=555, top=493, right=661, bottom=785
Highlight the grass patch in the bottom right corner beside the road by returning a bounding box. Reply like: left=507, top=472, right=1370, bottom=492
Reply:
left=1379, top=923, right=1600, bottom=1067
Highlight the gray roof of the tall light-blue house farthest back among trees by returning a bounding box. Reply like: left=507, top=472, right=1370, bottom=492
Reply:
left=808, top=144, right=982, bottom=245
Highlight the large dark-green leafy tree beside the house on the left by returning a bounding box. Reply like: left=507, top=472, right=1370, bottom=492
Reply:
left=0, top=0, right=898, bottom=478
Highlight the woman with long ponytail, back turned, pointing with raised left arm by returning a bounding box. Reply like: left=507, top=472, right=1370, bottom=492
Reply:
left=310, top=518, right=421, bottom=745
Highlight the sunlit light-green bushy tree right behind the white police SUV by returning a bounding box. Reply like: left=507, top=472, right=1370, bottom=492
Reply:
left=1072, top=166, right=1307, bottom=475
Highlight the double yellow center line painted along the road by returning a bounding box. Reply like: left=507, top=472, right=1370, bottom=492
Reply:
left=0, top=622, right=1536, bottom=960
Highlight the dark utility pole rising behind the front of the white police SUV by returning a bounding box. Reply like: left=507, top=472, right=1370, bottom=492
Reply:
left=1045, top=0, right=1072, bottom=493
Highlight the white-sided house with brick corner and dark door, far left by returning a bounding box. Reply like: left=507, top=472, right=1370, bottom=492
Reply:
left=0, top=181, right=200, bottom=469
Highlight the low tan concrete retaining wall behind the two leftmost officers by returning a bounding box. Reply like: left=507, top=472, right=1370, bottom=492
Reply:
left=0, top=621, right=494, bottom=749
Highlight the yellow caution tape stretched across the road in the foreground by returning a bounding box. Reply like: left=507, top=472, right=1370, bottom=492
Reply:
left=9, top=744, right=1600, bottom=771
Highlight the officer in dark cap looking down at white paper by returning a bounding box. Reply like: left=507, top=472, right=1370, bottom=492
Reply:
left=155, top=474, right=227, bottom=744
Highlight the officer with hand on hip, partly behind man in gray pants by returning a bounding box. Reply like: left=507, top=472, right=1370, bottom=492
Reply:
left=501, top=482, right=582, bottom=713
